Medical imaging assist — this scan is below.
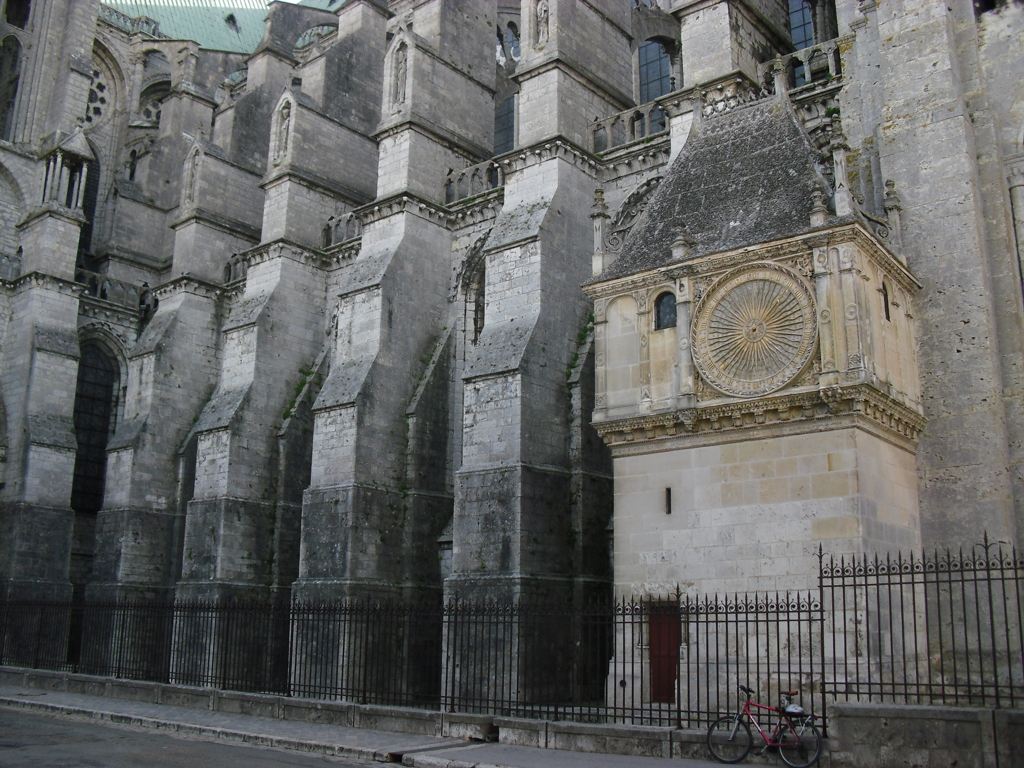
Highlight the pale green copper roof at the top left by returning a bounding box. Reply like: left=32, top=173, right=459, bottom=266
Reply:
left=103, top=0, right=267, bottom=53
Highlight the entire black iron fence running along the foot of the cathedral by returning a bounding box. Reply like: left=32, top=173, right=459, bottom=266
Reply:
left=0, top=540, right=1024, bottom=727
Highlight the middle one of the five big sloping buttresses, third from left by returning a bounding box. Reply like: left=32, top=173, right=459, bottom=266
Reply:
left=177, top=244, right=325, bottom=596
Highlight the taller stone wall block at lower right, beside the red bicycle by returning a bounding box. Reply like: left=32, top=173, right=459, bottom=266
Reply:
left=828, top=703, right=1024, bottom=768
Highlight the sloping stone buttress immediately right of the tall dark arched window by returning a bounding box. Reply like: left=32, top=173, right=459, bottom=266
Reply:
left=88, top=279, right=219, bottom=599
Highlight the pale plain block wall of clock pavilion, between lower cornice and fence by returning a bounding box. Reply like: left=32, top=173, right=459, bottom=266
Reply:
left=613, top=424, right=920, bottom=595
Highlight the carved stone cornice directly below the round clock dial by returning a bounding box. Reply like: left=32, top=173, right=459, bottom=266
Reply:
left=593, top=384, right=927, bottom=453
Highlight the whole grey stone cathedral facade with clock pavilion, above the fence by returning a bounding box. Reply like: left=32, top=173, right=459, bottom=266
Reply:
left=0, top=0, right=1024, bottom=604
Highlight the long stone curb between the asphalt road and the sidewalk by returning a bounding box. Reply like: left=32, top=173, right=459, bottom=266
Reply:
left=0, top=696, right=399, bottom=763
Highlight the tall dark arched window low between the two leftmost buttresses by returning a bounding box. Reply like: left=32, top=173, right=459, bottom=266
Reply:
left=71, top=342, right=118, bottom=515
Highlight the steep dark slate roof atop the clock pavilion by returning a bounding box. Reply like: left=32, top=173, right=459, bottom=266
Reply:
left=594, top=97, right=828, bottom=282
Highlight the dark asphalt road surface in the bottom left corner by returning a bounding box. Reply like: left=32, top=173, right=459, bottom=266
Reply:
left=0, top=709, right=376, bottom=768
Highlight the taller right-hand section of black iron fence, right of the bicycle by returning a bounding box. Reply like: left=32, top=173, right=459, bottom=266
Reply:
left=820, top=536, right=1024, bottom=709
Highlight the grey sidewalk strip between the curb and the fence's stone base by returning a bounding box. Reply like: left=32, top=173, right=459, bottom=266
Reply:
left=0, top=686, right=717, bottom=768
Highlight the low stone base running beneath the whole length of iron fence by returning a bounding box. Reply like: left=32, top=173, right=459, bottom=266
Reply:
left=0, top=667, right=1024, bottom=768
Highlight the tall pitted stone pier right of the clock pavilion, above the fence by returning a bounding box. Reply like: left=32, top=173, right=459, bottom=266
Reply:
left=868, top=3, right=1020, bottom=542
